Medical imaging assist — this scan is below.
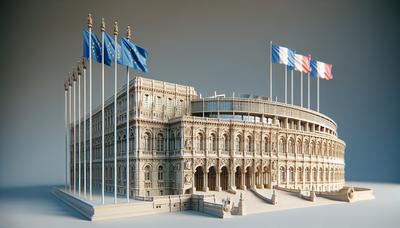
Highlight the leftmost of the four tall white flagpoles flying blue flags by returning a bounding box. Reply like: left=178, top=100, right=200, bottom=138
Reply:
left=88, top=14, right=93, bottom=200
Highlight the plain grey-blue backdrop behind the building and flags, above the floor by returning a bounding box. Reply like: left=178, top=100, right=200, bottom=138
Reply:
left=0, top=1, right=400, bottom=187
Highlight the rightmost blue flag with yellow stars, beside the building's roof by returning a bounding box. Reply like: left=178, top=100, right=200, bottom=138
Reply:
left=121, top=38, right=148, bottom=73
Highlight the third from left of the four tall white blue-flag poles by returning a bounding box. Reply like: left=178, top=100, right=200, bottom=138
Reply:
left=114, top=22, right=118, bottom=203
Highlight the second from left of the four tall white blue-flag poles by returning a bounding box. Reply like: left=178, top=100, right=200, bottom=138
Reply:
left=100, top=18, right=106, bottom=204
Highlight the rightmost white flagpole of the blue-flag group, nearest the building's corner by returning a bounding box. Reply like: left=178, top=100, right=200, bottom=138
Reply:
left=126, top=26, right=131, bottom=203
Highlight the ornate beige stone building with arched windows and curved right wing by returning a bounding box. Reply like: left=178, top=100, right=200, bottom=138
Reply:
left=69, top=77, right=345, bottom=197
